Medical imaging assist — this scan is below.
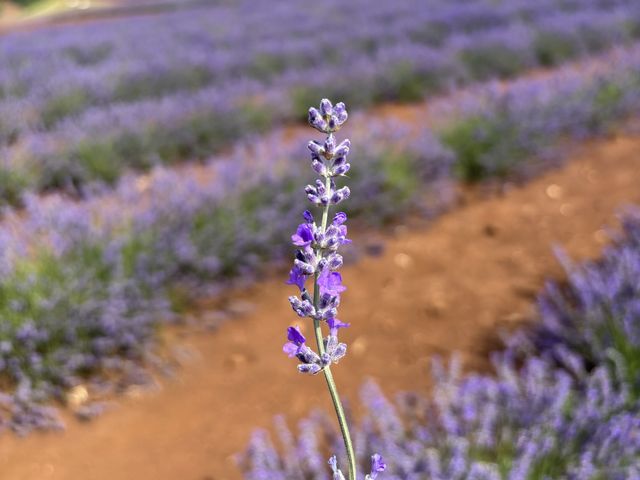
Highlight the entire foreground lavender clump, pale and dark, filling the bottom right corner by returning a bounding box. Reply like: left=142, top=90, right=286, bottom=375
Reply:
left=241, top=212, right=640, bottom=480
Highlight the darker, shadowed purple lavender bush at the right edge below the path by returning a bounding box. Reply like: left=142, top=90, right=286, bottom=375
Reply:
left=509, top=212, right=640, bottom=398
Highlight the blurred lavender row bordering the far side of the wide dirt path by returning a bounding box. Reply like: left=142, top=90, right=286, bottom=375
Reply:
left=0, top=48, right=640, bottom=432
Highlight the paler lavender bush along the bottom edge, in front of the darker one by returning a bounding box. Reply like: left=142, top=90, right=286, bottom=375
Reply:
left=241, top=355, right=640, bottom=480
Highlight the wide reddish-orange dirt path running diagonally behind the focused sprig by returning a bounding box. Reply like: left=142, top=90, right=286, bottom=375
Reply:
left=0, top=133, right=640, bottom=480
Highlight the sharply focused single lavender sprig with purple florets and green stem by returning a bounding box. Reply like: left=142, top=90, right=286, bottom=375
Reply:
left=283, top=98, right=386, bottom=480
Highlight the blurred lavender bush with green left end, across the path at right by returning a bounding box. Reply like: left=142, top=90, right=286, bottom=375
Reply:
left=438, top=45, right=640, bottom=181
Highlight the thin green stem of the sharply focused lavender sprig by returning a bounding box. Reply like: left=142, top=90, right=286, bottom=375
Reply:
left=313, top=172, right=356, bottom=480
